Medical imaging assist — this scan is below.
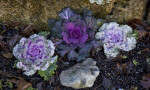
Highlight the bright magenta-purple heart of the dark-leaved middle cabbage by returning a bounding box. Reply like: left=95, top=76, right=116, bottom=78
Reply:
left=62, top=21, right=88, bottom=44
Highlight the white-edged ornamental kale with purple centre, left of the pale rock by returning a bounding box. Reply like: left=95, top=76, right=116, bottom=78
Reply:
left=13, top=34, right=57, bottom=76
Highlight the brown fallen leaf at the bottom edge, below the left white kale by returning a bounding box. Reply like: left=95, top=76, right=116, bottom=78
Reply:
left=8, top=77, right=32, bottom=90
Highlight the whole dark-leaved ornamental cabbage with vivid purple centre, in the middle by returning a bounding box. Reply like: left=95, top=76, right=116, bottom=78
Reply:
left=48, top=8, right=98, bottom=61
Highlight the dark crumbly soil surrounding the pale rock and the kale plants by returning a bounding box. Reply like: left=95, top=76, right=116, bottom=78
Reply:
left=0, top=21, right=150, bottom=90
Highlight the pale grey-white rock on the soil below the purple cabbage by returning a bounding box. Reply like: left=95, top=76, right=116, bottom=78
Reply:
left=60, top=58, right=99, bottom=89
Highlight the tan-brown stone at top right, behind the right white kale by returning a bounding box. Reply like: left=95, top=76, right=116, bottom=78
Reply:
left=106, top=0, right=148, bottom=23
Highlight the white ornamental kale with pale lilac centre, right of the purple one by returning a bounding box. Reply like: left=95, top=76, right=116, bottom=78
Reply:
left=95, top=22, right=136, bottom=58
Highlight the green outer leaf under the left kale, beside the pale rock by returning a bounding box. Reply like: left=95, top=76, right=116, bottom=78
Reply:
left=38, top=64, right=58, bottom=81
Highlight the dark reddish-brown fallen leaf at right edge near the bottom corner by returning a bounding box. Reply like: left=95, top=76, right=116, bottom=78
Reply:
left=140, top=74, right=150, bottom=88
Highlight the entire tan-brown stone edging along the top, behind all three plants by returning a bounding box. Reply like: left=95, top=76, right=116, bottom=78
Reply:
left=0, top=0, right=148, bottom=30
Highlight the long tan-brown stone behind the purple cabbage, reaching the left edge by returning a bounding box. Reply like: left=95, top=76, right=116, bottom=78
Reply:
left=0, top=0, right=115, bottom=29
